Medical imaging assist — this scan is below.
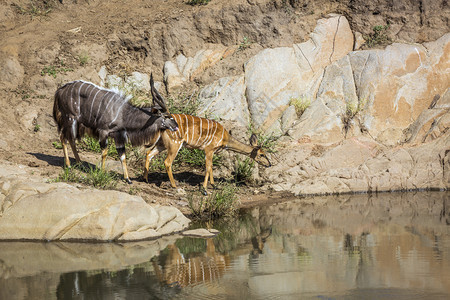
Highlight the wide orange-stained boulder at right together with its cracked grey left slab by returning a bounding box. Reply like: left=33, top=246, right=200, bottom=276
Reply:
left=288, top=34, right=450, bottom=146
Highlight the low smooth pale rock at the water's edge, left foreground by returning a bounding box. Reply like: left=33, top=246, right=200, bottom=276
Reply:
left=0, top=166, right=190, bottom=241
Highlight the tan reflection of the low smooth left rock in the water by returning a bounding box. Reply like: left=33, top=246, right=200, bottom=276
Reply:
left=0, top=237, right=176, bottom=278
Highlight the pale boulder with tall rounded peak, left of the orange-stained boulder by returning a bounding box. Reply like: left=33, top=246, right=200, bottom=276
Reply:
left=245, top=16, right=353, bottom=130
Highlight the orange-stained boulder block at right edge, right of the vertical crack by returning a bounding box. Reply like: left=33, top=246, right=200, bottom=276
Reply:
left=349, top=33, right=450, bottom=137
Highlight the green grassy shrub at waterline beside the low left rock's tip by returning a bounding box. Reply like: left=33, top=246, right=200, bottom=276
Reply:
left=188, top=182, right=238, bottom=220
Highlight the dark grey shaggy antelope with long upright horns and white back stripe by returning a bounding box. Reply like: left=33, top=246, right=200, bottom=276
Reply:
left=53, top=75, right=178, bottom=183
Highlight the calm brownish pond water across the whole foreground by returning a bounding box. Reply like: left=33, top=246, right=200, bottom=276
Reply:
left=0, top=192, right=450, bottom=299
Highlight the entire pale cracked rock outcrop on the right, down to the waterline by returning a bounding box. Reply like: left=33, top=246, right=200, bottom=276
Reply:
left=164, top=16, right=450, bottom=195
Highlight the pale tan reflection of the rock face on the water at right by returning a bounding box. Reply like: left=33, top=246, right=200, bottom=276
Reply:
left=241, top=193, right=450, bottom=296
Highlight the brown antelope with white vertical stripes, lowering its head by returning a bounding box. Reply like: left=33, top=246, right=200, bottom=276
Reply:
left=144, top=114, right=271, bottom=194
